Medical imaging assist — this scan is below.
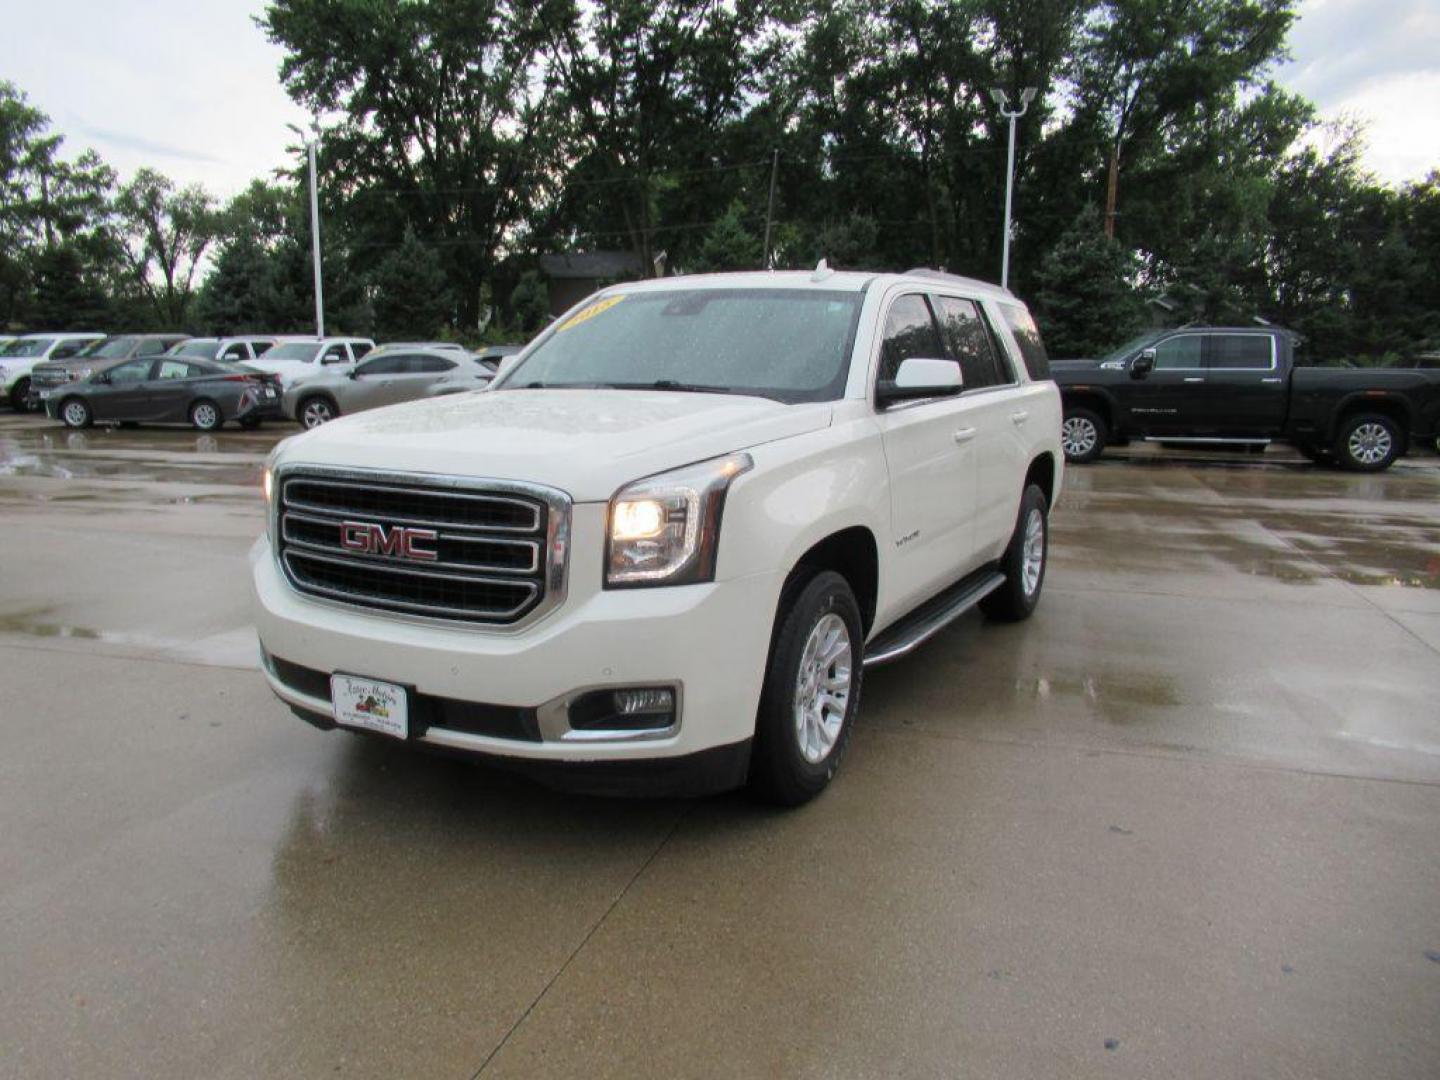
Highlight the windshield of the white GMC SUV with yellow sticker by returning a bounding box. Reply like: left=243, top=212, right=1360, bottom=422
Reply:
left=504, top=289, right=861, bottom=402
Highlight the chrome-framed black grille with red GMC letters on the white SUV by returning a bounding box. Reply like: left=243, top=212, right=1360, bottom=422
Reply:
left=275, top=471, right=567, bottom=625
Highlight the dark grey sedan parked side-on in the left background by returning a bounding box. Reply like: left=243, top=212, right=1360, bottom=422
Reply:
left=40, top=356, right=282, bottom=431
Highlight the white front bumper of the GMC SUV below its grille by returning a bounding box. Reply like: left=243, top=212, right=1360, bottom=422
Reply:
left=251, top=529, right=782, bottom=793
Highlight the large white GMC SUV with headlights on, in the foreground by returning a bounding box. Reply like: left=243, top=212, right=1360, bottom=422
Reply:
left=252, top=264, right=1063, bottom=804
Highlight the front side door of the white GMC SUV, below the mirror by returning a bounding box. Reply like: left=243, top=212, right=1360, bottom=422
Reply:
left=876, top=292, right=979, bottom=609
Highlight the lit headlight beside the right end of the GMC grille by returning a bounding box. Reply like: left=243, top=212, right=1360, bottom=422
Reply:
left=605, top=454, right=755, bottom=588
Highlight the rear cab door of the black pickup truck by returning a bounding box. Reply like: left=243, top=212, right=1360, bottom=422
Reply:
left=1202, top=330, right=1287, bottom=438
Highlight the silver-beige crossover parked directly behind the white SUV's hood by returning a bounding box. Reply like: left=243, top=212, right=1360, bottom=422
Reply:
left=285, top=346, right=494, bottom=428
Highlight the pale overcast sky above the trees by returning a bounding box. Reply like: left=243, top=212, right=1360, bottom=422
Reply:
left=0, top=0, right=1440, bottom=197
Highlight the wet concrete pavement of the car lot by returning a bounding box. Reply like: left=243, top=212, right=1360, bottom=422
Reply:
left=0, top=413, right=1440, bottom=1077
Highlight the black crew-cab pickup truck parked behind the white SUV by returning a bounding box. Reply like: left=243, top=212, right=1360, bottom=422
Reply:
left=1051, top=327, right=1440, bottom=472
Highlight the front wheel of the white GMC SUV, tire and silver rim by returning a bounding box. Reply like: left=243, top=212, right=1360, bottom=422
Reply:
left=750, top=570, right=864, bottom=806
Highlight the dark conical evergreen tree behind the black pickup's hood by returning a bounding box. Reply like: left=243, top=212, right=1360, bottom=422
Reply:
left=1035, top=206, right=1145, bottom=357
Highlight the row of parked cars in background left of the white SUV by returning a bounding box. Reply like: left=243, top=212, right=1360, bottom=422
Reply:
left=0, top=333, right=520, bottom=431
